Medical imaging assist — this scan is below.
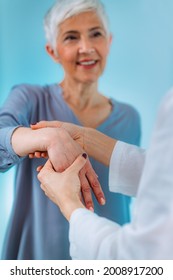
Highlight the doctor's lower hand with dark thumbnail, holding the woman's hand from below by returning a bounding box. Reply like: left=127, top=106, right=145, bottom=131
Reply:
left=37, top=153, right=87, bottom=220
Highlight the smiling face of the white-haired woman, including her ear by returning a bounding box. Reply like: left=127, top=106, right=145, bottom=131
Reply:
left=47, top=12, right=111, bottom=83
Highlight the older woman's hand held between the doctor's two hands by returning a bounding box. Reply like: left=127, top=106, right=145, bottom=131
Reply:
left=45, top=127, right=105, bottom=210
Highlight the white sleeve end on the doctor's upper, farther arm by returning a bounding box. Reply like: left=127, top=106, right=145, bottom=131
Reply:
left=109, top=141, right=145, bottom=196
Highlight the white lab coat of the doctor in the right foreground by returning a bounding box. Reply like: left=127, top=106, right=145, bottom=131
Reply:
left=69, top=91, right=173, bottom=259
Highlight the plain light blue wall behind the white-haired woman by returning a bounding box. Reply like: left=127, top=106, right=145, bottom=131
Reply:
left=0, top=0, right=173, bottom=258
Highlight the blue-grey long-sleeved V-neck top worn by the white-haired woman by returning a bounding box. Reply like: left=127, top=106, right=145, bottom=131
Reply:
left=0, top=84, right=141, bottom=260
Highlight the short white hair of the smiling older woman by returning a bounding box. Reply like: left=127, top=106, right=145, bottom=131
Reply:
left=44, top=0, right=109, bottom=49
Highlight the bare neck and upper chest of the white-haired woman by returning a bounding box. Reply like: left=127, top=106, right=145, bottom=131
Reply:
left=60, top=77, right=112, bottom=128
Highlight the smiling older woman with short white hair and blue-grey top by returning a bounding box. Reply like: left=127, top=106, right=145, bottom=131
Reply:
left=0, top=0, right=140, bottom=259
